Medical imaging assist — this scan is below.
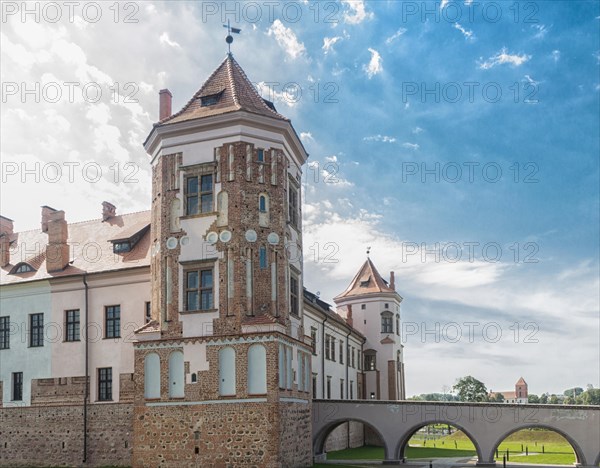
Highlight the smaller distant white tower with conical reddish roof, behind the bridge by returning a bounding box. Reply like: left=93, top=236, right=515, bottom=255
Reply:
left=333, top=258, right=406, bottom=400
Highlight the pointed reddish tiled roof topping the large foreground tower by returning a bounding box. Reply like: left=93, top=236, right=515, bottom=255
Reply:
left=155, top=54, right=289, bottom=126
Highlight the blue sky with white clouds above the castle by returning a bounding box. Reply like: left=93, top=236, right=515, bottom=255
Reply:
left=0, top=0, right=600, bottom=395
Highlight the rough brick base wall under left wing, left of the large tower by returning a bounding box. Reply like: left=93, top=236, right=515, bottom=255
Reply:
left=0, top=403, right=133, bottom=467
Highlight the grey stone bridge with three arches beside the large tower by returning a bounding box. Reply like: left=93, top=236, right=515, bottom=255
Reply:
left=313, top=400, right=600, bottom=467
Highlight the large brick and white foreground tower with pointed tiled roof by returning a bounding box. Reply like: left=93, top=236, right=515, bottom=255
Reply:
left=133, top=54, right=312, bottom=468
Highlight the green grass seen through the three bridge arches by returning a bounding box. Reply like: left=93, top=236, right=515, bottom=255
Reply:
left=315, top=429, right=575, bottom=468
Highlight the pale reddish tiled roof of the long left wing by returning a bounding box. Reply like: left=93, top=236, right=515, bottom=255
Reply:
left=0, top=211, right=151, bottom=285
